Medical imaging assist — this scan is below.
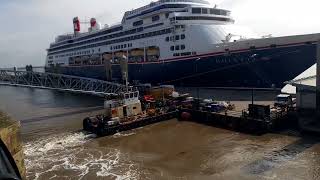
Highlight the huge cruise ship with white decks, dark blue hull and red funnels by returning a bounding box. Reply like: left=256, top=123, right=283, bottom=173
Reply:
left=46, top=0, right=320, bottom=88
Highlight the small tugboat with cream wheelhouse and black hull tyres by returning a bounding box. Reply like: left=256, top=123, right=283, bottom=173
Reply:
left=83, top=88, right=177, bottom=136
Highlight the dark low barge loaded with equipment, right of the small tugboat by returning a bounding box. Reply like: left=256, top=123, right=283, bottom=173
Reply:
left=178, top=100, right=294, bottom=134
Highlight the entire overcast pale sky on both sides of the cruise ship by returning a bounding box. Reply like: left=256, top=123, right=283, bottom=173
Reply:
left=0, top=0, right=320, bottom=67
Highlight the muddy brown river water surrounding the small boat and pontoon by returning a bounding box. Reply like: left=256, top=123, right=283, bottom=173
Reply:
left=0, top=86, right=320, bottom=180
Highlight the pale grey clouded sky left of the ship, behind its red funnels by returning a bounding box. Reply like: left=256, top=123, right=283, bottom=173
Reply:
left=0, top=0, right=149, bottom=67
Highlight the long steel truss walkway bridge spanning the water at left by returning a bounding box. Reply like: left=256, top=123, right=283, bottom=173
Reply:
left=0, top=70, right=132, bottom=96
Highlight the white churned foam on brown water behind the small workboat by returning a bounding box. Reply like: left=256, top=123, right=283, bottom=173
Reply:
left=24, top=133, right=139, bottom=180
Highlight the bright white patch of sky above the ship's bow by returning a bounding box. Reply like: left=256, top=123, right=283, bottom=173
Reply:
left=220, top=0, right=320, bottom=36
